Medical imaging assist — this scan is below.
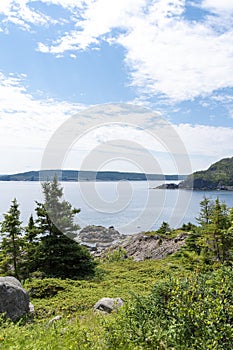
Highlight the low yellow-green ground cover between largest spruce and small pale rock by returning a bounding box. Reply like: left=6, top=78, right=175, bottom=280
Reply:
left=24, top=260, right=180, bottom=319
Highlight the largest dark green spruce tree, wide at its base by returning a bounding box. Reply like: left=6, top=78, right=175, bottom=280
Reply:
left=35, top=177, right=95, bottom=278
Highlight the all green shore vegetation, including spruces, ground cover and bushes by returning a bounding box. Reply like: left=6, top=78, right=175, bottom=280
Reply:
left=0, top=183, right=233, bottom=350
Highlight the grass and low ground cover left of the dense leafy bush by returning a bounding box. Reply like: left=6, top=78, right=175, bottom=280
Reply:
left=0, top=258, right=185, bottom=350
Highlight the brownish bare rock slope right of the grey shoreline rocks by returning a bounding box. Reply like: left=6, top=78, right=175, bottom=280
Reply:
left=106, top=233, right=187, bottom=261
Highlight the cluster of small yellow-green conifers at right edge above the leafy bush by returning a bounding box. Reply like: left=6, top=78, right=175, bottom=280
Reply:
left=181, top=197, right=233, bottom=266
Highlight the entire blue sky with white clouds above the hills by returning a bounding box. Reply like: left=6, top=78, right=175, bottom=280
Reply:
left=0, top=0, right=233, bottom=174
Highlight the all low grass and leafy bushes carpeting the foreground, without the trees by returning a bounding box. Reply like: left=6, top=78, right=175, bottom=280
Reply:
left=0, top=255, right=233, bottom=350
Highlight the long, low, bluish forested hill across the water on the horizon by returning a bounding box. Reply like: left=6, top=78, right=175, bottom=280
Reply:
left=0, top=170, right=186, bottom=181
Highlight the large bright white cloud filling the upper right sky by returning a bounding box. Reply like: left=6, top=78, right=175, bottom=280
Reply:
left=33, top=0, right=233, bottom=101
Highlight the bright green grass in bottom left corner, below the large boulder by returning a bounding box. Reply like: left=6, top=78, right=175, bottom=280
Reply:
left=0, top=314, right=106, bottom=350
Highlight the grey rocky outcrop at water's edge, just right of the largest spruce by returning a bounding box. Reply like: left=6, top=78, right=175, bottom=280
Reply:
left=78, top=225, right=125, bottom=253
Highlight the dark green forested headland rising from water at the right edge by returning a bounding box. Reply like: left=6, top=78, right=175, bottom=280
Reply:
left=178, top=157, right=233, bottom=190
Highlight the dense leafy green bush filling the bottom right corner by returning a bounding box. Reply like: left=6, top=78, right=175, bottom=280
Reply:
left=105, top=267, right=233, bottom=350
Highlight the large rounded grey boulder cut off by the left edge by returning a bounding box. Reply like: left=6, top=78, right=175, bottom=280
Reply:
left=0, top=276, right=32, bottom=321
